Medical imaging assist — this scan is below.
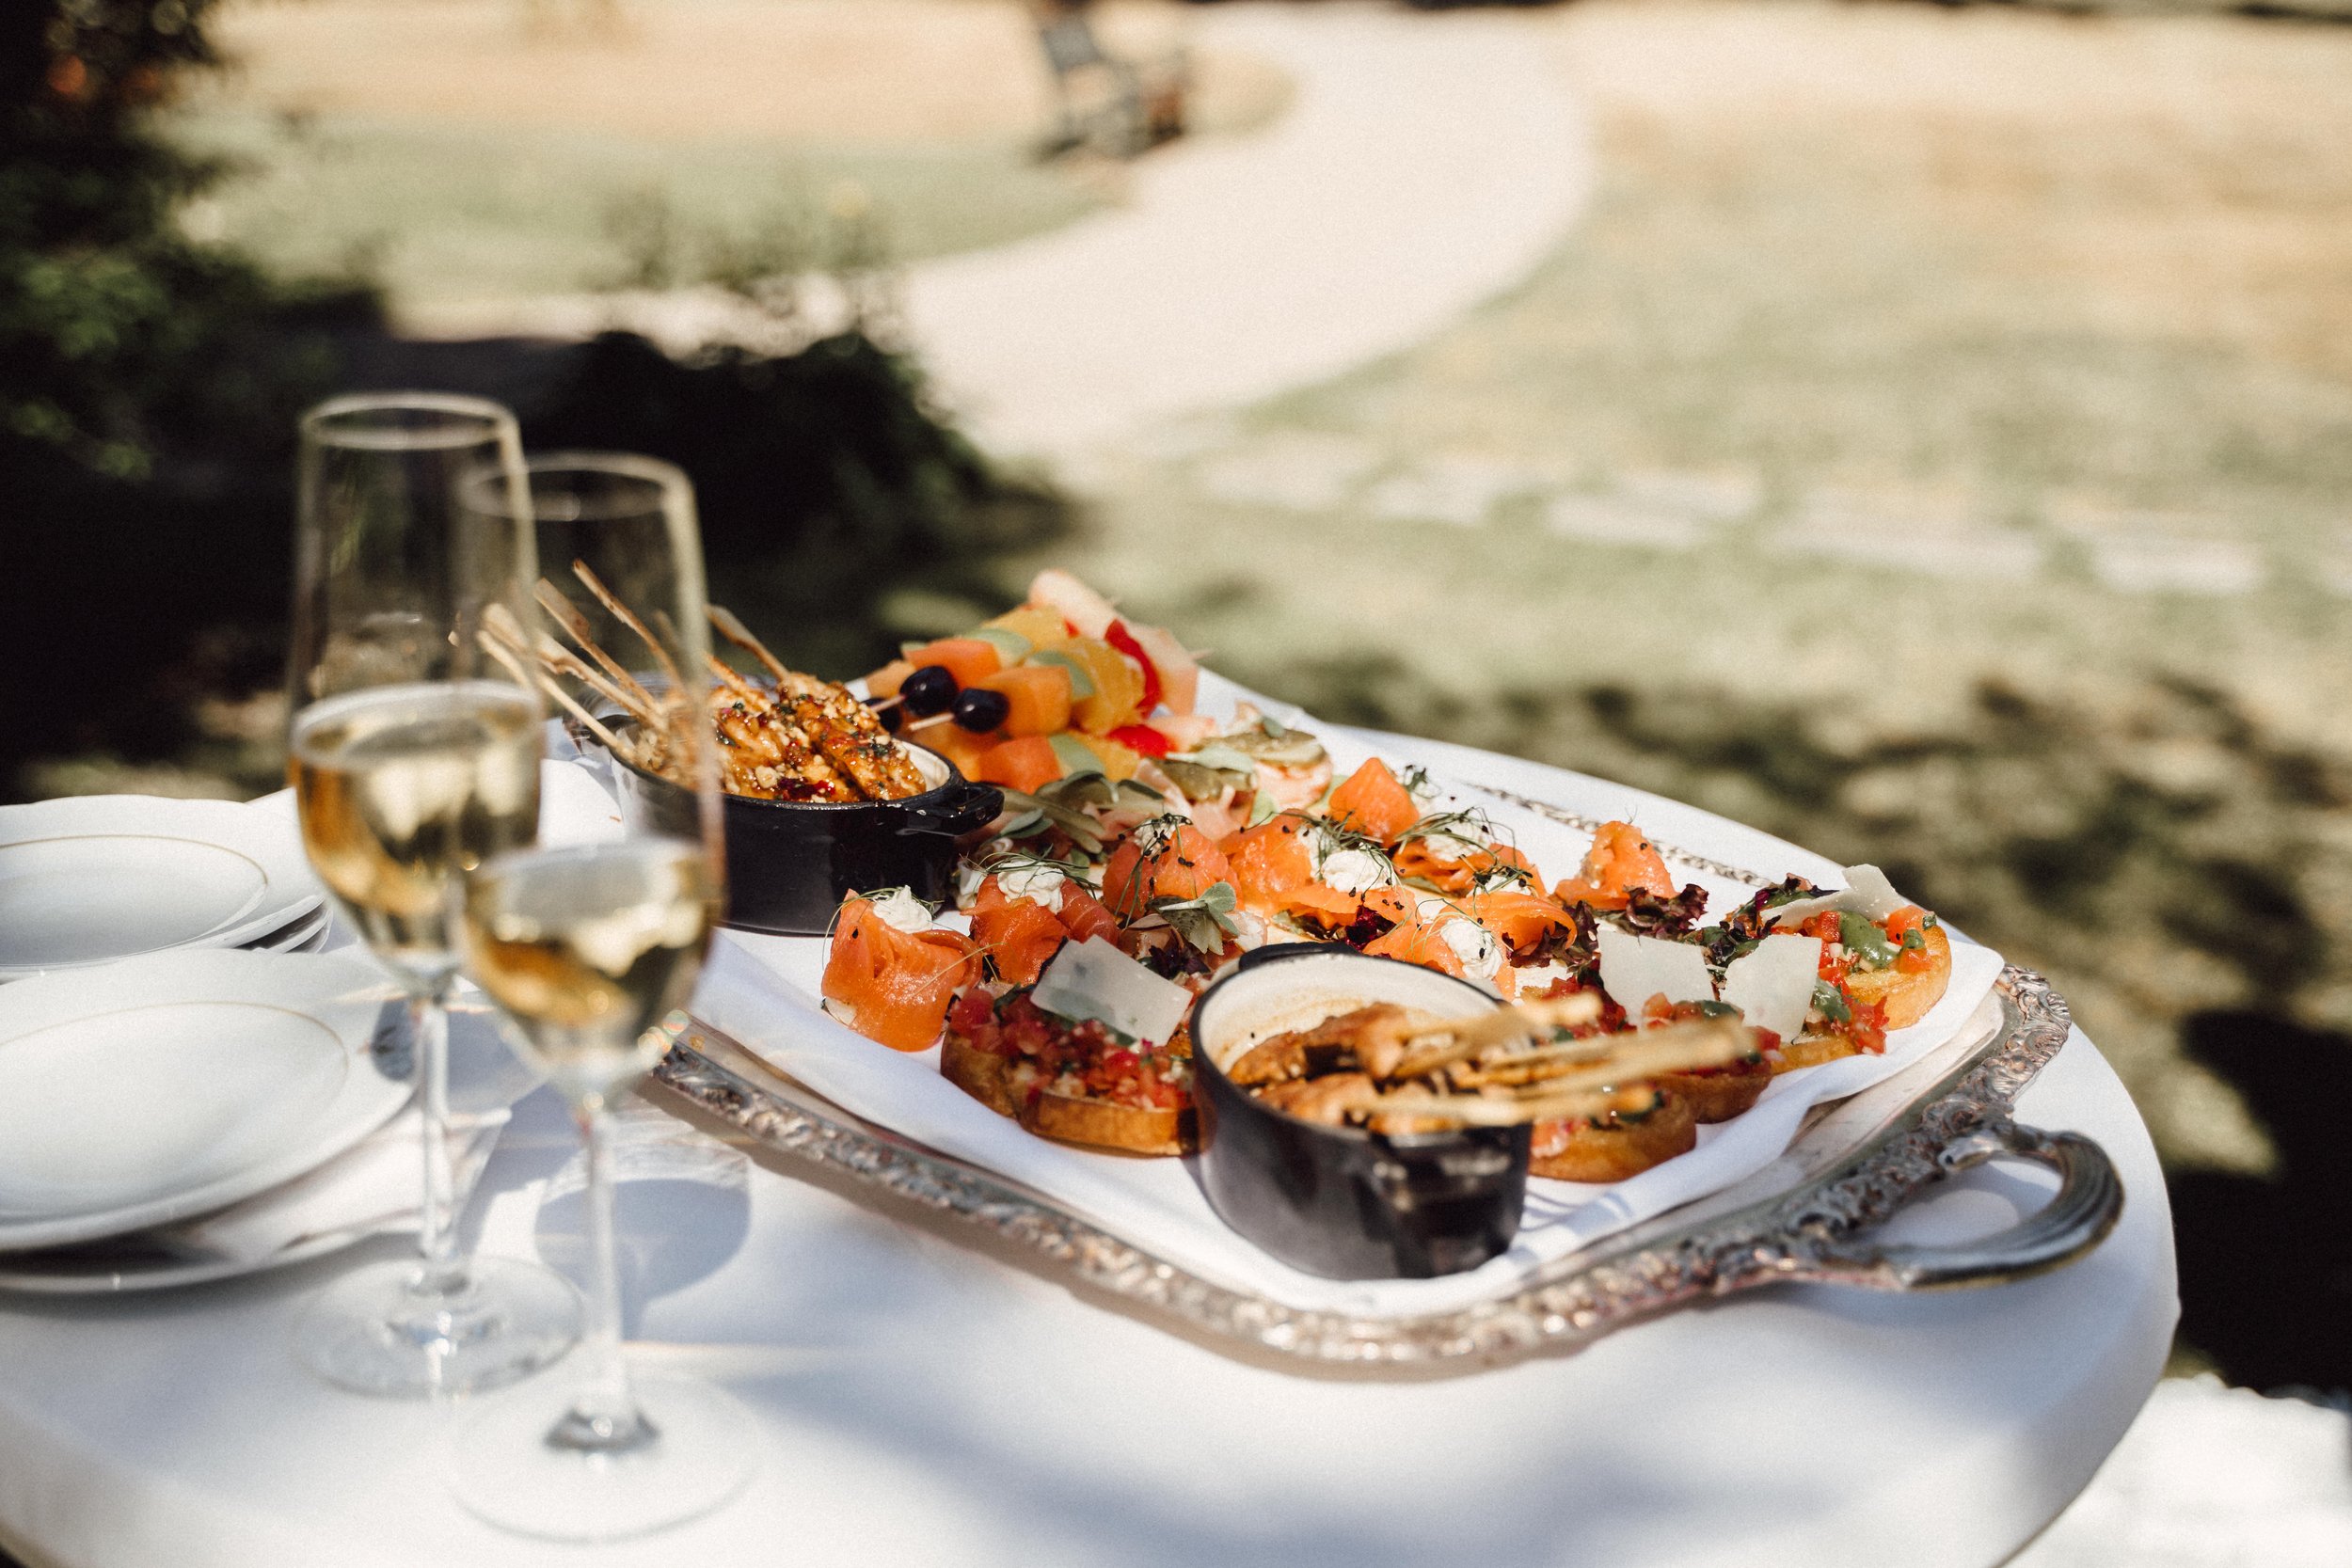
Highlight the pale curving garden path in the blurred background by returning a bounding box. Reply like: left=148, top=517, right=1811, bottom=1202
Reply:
left=906, top=5, right=1593, bottom=453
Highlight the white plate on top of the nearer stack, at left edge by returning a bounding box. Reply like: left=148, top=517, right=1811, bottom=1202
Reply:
left=0, top=950, right=409, bottom=1251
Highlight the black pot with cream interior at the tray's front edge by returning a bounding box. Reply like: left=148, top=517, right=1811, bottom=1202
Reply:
left=1193, top=945, right=1532, bottom=1279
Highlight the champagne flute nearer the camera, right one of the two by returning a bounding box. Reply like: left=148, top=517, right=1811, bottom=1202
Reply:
left=452, top=456, right=757, bottom=1540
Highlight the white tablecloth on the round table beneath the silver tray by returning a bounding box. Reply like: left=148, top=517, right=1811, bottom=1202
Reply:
left=0, top=1037, right=2176, bottom=1568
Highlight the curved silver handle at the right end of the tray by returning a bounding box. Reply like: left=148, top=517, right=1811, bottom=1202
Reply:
left=1795, top=1121, right=2124, bottom=1291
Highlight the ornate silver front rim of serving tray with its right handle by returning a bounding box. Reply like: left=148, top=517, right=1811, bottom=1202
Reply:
left=654, top=966, right=2124, bottom=1366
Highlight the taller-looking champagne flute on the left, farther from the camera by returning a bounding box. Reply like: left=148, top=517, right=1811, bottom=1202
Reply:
left=290, top=392, right=579, bottom=1397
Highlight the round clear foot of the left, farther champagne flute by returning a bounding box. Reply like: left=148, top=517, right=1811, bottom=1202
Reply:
left=294, top=1258, right=581, bottom=1399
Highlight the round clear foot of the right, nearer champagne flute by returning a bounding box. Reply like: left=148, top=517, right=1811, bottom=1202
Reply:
left=450, top=1378, right=760, bottom=1543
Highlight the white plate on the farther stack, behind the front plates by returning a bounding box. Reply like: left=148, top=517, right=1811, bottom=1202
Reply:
left=0, top=795, right=325, bottom=980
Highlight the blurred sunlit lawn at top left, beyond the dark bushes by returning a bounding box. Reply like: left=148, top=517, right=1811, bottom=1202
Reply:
left=169, top=0, right=1289, bottom=305
